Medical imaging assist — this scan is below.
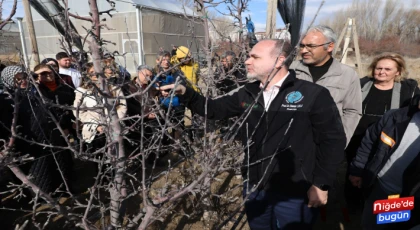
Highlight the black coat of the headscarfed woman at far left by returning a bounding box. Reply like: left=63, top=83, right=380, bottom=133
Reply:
left=1, top=90, right=72, bottom=193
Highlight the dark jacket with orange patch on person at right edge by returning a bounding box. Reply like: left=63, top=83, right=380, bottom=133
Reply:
left=349, top=96, right=420, bottom=197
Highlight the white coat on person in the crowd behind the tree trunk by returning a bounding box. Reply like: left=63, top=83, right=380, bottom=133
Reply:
left=73, top=87, right=127, bottom=143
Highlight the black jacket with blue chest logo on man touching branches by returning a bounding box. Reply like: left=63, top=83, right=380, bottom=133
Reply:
left=180, top=71, right=346, bottom=197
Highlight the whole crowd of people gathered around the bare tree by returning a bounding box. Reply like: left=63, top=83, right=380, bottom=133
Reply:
left=0, top=25, right=420, bottom=229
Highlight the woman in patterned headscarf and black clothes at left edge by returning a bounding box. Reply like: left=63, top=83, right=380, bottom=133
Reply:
left=1, top=66, right=69, bottom=193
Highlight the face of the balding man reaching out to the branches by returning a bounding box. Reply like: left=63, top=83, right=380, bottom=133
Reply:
left=245, top=41, right=277, bottom=81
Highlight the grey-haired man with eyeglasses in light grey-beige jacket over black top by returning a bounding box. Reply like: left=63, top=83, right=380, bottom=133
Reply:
left=290, top=25, right=362, bottom=144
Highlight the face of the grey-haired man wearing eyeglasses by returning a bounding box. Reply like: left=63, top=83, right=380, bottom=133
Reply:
left=300, top=31, right=334, bottom=66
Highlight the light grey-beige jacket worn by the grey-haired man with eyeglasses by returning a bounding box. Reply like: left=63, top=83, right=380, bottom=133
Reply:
left=290, top=59, right=362, bottom=144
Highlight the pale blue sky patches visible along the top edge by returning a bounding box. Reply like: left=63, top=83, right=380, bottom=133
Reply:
left=3, top=0, right=412, bottom=32
